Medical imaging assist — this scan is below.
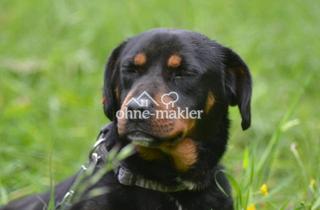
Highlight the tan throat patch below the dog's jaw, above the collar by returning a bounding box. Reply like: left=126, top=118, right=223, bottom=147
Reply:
left=164, top=138, right=198, bottom=172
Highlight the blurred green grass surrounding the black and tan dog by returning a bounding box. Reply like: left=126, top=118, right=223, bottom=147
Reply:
left=0, top=0, right=320, bottom=210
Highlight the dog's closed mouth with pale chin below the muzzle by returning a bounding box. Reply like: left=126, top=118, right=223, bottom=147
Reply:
left=126, top=131, right=183, bottom=148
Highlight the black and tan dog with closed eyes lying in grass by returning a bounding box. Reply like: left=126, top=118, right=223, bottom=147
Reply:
left=2, top=29, right=251, bottom=210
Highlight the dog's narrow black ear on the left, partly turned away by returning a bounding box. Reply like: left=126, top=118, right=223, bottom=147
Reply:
left=103, top=42, right=126, bottom=120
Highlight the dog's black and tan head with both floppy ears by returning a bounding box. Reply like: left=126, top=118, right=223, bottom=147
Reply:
left=104, top=29, right=251, bottom=171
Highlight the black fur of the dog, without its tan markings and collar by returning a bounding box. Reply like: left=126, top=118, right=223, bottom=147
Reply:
left=1, top=29, right=252, bottom=210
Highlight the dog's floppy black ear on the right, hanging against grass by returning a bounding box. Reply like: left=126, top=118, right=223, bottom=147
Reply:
left=224, top=48, right=252, bottom=130
